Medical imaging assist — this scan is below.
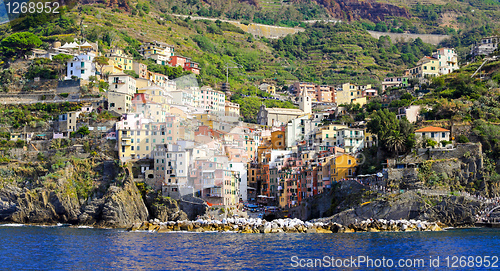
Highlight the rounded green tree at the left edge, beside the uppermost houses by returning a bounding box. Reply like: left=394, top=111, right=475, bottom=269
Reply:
left=0, top=32, right=43, bottom=57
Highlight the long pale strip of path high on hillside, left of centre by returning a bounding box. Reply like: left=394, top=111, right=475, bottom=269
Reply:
left=170, top=14, right=305, bottom=39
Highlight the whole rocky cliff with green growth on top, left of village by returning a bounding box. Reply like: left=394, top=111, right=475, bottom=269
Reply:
left=0, top=161, right=203, bottom=228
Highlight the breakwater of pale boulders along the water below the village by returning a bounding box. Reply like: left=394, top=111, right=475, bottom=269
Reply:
left=128, top=218, right=442, bottom=233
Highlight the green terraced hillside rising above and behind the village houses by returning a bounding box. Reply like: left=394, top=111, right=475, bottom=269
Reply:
left=0, top=1, right=495, bottom=124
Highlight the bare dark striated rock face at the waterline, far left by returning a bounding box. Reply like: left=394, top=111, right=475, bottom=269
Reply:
left=0, top=181, right=149, bottom=228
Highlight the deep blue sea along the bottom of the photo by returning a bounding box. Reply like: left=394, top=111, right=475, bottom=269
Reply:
left=0, top=224, right=500, bottom=270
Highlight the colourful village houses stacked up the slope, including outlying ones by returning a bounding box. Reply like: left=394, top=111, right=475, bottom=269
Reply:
left=23, top=39, right=458, bottom=207
